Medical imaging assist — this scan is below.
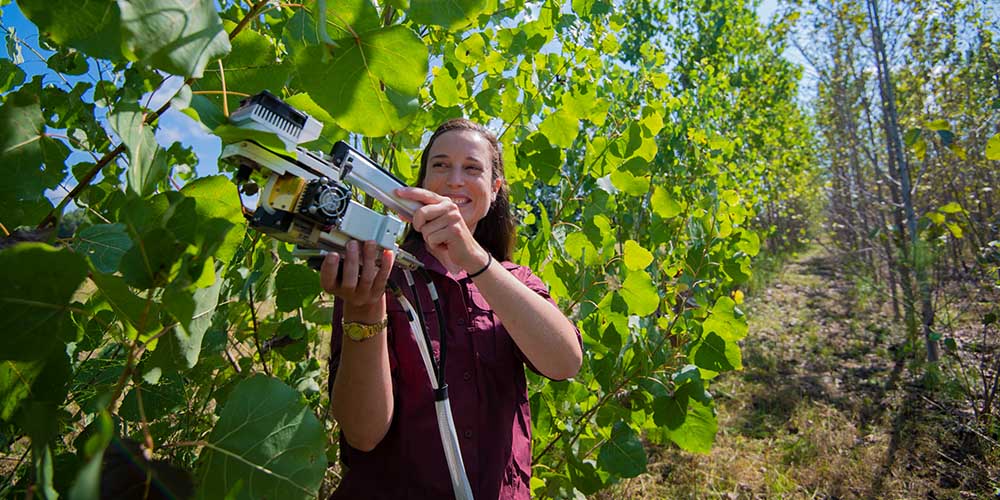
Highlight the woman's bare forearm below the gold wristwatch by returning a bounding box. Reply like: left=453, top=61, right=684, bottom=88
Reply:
left=330, top=306, right=393, bottom=451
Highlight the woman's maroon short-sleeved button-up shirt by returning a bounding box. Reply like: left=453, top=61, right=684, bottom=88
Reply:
left=330, top=246, right=579, bottom=500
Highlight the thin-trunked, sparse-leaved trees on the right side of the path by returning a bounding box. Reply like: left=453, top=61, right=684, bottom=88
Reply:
left=789, top=0, right=1000, bottom=422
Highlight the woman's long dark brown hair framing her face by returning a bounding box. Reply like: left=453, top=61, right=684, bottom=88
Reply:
left=406, top=118, right=517, bottom=261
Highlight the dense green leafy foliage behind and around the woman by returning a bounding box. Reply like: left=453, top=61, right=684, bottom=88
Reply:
left=0, top=0, right=822, bottom=498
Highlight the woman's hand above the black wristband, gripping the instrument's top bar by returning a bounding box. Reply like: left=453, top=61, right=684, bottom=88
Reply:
left=396, top=187, right=488, bottom=272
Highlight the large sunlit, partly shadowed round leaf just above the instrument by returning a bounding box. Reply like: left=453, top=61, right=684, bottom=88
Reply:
left=295, top=25, right=427, bottom=137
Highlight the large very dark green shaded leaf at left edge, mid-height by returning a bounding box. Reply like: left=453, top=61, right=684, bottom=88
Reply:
left=0, top=243, right=87, bottom=361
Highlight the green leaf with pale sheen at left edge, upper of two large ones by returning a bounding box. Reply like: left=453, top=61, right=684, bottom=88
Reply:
left=0, top=85, right=66, bottom=200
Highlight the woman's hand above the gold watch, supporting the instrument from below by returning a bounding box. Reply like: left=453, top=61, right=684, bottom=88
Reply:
left=319, top=240, right=395, bottom=323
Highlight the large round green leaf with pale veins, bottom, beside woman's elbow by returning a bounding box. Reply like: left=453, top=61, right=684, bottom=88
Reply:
left=197, top=375, right=327, bottom=499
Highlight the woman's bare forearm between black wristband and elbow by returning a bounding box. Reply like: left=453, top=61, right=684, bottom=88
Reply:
left=473, top=263, right=583, bottom=380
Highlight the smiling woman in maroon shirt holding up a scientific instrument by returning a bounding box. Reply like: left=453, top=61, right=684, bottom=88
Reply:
left=320, top=119, right=583, bottom=499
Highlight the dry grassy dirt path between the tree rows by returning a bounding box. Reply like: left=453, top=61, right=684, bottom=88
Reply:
left=600, top=246, right=1000, bottom=499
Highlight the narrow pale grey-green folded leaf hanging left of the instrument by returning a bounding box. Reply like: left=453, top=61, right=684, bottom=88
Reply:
left=108, top=101, right=168, bottom=197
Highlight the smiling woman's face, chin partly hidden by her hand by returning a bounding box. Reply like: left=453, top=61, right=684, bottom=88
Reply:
left=423, top=130, right=500, bottom=232
